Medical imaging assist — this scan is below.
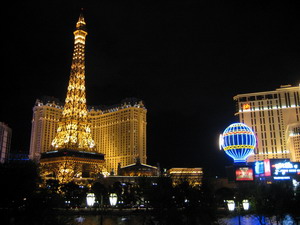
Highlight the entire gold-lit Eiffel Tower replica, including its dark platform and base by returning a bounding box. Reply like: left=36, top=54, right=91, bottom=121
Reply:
left=40, top=14, right=105, bottom=185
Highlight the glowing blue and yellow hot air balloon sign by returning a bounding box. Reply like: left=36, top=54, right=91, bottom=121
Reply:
left=220, top=123, right=256, bottom=164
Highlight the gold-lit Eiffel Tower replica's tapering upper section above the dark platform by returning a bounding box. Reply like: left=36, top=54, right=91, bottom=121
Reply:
left=52, top=13, right=95, bottom=151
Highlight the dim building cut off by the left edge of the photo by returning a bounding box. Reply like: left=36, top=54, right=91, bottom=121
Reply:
left=0, top=122, right=12, bottom=163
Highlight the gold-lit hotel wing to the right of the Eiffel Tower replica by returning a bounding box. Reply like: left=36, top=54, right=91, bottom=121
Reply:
left=89, top=99, right=147, bottom=173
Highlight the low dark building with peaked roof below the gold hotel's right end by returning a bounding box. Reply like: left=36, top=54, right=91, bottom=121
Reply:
left=118, top=160, right=160, bottom=177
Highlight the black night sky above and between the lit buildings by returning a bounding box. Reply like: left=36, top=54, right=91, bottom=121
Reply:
left=0, top=0, right=300, bottom=174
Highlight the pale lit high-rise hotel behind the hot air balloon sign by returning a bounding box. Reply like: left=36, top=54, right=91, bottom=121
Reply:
left=234, top=85, right=300, bottom=162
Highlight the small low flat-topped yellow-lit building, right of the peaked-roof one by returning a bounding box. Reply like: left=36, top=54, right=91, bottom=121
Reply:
left=168, top=168, right=203, bottom=187
